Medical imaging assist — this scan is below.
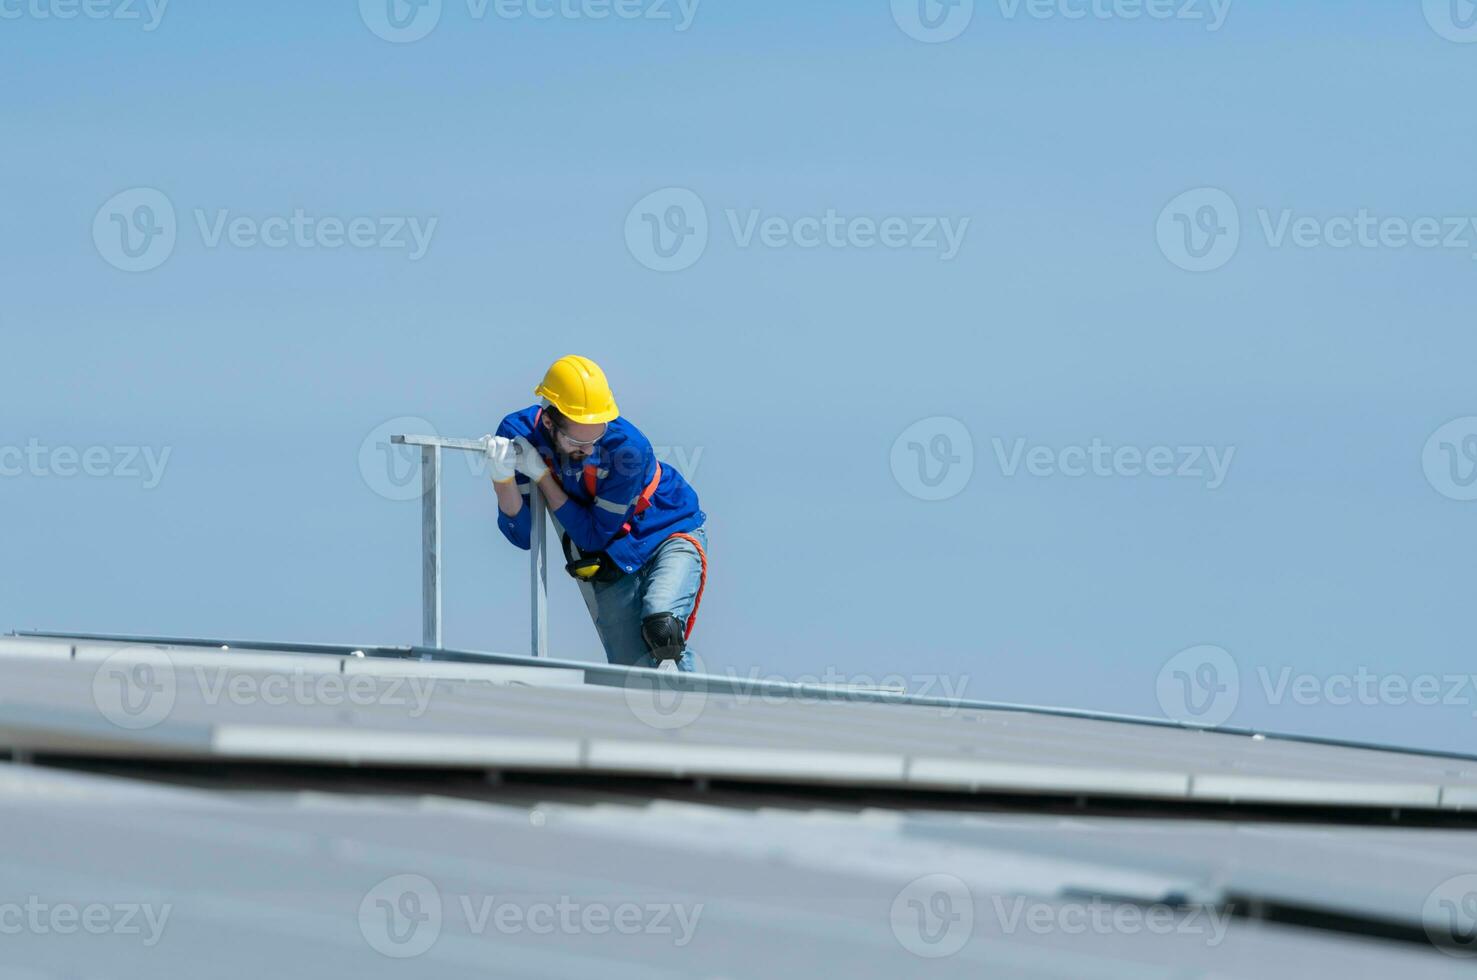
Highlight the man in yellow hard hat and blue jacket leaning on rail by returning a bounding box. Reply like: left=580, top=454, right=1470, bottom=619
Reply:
left=483, top=354, right=707, bottom=672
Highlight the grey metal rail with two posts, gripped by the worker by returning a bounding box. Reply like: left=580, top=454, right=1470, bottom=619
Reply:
left=390, top=435, right=549, bottom=657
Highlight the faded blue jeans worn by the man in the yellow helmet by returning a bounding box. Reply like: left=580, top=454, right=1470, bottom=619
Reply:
left=586, top=527, right=707, bottom=673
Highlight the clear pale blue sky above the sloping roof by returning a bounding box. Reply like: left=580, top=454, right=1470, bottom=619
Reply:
left=0, top=0, right=1477, bottom=750
